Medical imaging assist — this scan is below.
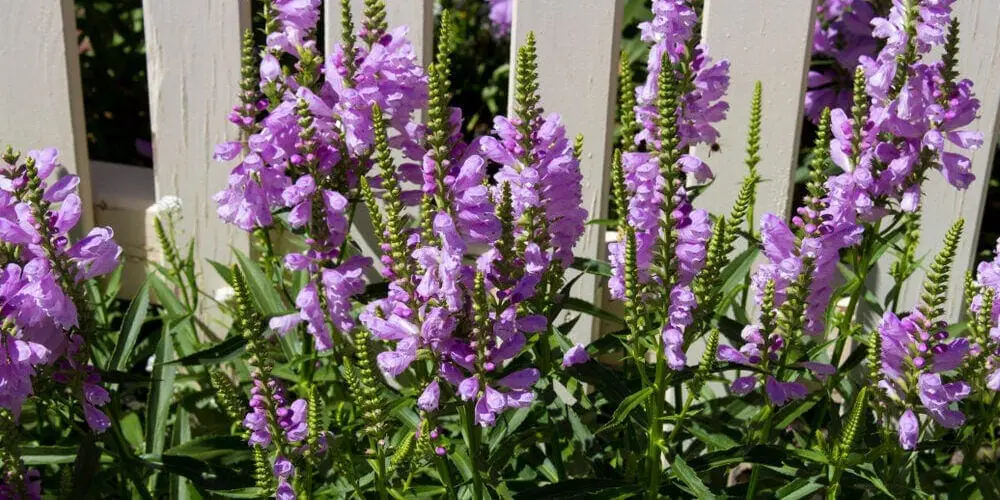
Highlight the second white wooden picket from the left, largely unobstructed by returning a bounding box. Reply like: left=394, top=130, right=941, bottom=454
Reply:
left=143, top=0, right=250, bottom=312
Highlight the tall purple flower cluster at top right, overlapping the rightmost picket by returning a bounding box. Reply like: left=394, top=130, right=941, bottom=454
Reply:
left=830, top=0, right=983, bottom=217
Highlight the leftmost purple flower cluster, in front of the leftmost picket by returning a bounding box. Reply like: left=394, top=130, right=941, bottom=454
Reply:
left=0, top=149, right=122, bottom=432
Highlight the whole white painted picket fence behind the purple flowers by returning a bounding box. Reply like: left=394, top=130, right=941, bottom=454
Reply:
left=0, top=0, right=1000, bottom=337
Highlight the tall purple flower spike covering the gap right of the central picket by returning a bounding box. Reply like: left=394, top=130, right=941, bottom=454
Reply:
left=608, top=0, right=729, bottom=370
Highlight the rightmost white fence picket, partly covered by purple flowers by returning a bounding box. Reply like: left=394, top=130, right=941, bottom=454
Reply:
left=889, top=0, right=1000, bottom=321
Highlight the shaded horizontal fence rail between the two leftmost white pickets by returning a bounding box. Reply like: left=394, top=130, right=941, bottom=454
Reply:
left=90, top=161, right=159, bottom=298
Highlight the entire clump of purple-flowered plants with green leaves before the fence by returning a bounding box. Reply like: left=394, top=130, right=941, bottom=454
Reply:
left=0, top=0, right=1000, bottom=499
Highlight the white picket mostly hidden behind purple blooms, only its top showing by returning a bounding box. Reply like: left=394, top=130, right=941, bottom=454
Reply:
left=323, top=0, right=434, bottom=64
